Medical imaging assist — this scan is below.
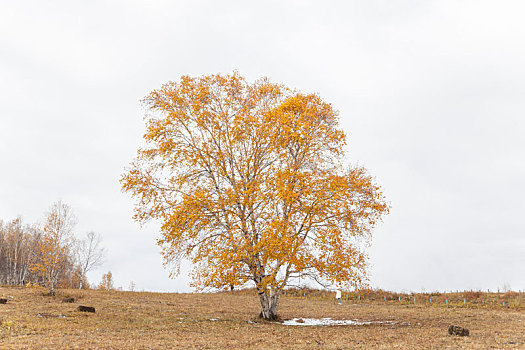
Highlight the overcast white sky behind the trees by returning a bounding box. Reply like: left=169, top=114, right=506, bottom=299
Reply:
left=0, top=0, right=525, bottom=291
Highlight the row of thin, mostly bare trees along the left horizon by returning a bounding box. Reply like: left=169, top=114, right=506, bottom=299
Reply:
left=0, top=201, right=105, bottom=294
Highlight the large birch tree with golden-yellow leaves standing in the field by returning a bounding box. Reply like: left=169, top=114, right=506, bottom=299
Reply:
left=121, top=73, right=388, bottom=320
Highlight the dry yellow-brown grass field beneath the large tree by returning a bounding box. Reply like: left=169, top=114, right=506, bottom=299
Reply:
left=0, top=287, right=525, bottom=349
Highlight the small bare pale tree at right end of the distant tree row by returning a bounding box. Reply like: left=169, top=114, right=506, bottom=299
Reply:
left=77, top=231, right=106, bottom=289
